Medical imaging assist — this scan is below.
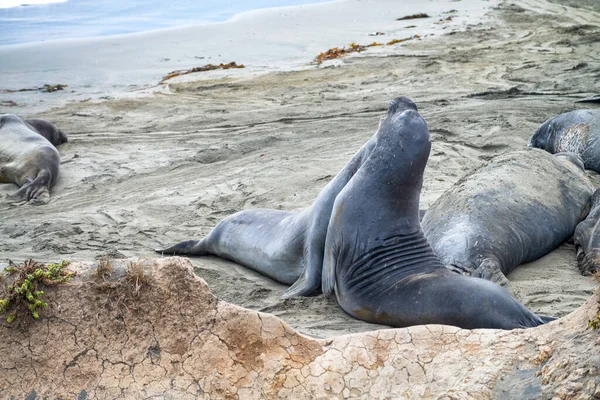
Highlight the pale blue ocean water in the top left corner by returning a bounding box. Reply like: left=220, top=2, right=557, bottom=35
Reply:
left=0, top=0, right=327, bottom=46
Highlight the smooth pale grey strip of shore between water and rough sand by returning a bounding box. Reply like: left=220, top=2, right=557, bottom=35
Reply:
left=0, top=0, right=497, bottom=114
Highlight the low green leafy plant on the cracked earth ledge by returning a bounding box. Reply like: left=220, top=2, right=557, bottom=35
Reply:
left=0, top=259, right=73, bottom=323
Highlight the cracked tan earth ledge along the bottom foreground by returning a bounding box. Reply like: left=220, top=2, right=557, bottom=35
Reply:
left=0, top=257, right=600, bottom=399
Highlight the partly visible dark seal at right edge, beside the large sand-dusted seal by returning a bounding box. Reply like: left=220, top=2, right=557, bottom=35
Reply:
left=573, top=189, right=600, bottom=275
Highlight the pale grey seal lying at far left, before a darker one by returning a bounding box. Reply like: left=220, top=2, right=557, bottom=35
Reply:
left=0, top=114, right=60, bottom=205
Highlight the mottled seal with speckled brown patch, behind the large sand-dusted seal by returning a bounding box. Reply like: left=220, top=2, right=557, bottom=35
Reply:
left=528, top=110, right=600, bottom=173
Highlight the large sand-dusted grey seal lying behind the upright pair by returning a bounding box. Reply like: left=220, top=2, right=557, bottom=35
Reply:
left=422, top=148, right=593, bottom=283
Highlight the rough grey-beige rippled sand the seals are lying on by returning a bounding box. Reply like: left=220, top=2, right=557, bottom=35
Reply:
left=0, top=0, right=600, bottom=337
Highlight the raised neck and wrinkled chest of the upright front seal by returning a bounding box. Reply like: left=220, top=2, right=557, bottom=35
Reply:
left=332, top=112, right=441, bottom=285
